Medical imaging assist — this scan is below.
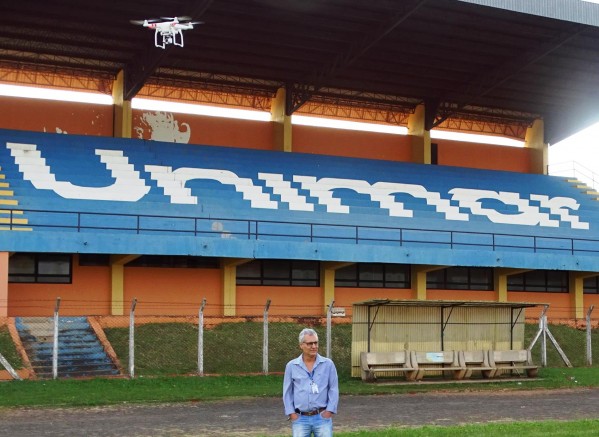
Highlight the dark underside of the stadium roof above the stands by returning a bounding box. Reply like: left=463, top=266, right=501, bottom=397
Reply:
left=0, top=0, right=599, bottom=143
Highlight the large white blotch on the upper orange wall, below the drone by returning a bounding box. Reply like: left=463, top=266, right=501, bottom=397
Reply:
left=134, top=111, right=191, bottom=144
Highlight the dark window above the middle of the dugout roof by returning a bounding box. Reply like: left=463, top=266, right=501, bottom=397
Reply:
left=426, top=267, right=493, bottom=291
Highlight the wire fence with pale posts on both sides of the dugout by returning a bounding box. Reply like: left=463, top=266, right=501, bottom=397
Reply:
left=0, top=305, right=599, bottom=379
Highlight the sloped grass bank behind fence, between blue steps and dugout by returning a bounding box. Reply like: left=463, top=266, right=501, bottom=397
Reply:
left=105, top=322, right=351, bottom=376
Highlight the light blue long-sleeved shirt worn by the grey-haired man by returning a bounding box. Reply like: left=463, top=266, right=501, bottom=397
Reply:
left=283, top=355, right=339, bottom=415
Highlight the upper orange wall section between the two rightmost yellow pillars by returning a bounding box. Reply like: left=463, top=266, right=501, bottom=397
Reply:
left=433, top=140, right=533, bottom=173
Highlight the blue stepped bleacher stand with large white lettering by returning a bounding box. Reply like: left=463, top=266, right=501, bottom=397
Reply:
left=0, top=127, right=599, bottom=270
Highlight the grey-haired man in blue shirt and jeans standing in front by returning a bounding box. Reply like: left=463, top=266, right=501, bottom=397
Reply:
left=283, top=328, right=339, bottom=437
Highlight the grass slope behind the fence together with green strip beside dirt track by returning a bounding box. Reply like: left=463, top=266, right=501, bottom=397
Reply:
left=0, top=322, right=599, bottom=407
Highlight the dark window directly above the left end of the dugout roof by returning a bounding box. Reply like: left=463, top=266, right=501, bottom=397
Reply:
left=335, top=263, right=411, bottom=288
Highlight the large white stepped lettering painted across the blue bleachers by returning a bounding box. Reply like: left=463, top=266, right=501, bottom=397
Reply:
left=6, top=143, right=589, bottom=229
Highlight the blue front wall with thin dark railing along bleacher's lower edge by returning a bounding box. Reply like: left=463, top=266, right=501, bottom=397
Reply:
left=7, top=209, right=599, bottom=255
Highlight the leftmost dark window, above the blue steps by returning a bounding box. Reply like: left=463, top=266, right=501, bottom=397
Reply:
left=8, top=253, right=72, bottom=284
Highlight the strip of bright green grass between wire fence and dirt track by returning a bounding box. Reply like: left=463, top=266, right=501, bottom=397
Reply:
left=0, top=368, right=599, bottom=407
